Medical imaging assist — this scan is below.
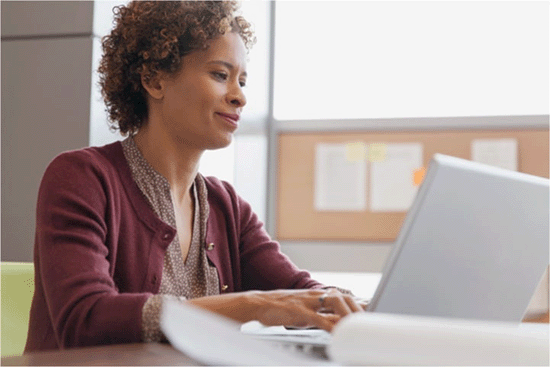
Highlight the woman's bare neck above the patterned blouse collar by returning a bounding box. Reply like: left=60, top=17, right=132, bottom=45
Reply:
left=134, top=124, right=203, bottom=204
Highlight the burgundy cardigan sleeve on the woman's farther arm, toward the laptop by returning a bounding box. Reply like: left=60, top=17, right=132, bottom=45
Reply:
left=218, top=182, right=323, bottom=290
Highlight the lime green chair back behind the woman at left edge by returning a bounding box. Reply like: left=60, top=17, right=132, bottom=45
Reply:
left=0, top=262, right=34, bottom=357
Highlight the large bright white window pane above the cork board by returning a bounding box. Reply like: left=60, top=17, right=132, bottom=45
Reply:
left=274, top=1, right=549, bottom=120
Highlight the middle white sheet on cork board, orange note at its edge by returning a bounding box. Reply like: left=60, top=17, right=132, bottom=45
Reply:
left=370, top=143, right=423, bottom=212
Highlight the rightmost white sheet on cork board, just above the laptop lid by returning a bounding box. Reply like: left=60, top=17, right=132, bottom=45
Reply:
left=471, top=138, right=518, bottom=171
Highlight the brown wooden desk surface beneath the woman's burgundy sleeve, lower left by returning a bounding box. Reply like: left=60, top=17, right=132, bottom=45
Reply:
left=2, top=343, right=199, bottom=366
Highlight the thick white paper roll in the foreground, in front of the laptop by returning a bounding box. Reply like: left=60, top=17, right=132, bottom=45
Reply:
left=328, top=312, right=549, bottom=366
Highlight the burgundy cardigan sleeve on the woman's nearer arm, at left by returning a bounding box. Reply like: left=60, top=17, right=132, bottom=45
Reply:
left=35, top=151, right=151, bottom=348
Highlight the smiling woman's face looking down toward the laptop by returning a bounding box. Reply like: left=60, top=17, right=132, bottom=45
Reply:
left=154, top=32, right=247, bottom=150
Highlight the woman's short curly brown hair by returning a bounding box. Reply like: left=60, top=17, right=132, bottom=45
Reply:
left=98, top=0, right=255, bottom=135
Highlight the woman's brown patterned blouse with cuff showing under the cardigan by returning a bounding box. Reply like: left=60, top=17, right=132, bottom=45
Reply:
left=122, top=137, right=220, bottom=342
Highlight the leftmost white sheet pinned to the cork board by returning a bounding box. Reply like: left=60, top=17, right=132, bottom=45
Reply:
left=314, top=144, right=367, bottom=211
